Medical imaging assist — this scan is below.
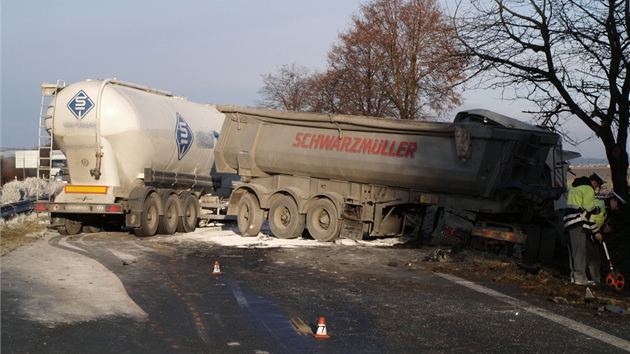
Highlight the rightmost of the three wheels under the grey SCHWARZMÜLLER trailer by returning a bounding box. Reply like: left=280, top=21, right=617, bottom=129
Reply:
left=306, top=199, right=341, bottom=242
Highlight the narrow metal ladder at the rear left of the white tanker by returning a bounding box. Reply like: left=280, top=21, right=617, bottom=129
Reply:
left=37, top=80, right=66, bottom=179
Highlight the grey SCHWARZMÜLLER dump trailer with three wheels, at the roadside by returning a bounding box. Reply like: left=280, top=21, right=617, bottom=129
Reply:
left=215, top=106, right=565, bottom=254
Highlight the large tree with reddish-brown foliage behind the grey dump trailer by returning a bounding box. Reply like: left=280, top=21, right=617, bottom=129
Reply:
left=328, top=0, right=465, bottom=119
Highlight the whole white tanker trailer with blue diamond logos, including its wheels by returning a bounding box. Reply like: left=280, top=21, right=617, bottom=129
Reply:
left=34, top=79, right=235, bottom=236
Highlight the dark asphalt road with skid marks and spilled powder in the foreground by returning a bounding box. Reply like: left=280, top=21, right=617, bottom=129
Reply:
left=1, top=228, right=630, bottom=353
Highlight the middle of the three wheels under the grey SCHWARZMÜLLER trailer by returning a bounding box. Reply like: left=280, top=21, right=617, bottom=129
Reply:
left=269, top=195, right=306, bottom=239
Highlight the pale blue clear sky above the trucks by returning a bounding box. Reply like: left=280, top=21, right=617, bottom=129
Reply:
left=0, top=0, right=604, bottom=158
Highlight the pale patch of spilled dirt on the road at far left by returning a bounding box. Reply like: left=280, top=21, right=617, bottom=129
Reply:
left=2, top=231, right=146, bottom=327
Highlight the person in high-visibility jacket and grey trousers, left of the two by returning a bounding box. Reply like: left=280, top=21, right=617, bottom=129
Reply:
left=564, top=173, right=605, bottom=285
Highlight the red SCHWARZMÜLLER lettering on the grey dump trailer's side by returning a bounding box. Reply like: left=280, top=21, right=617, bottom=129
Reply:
left=292, top=132, right=418, bottom=159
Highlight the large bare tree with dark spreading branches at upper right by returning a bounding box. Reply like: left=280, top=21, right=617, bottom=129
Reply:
left=454, top=0, right=630, bottom=200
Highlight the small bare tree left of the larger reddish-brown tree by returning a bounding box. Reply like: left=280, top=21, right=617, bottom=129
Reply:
left=258, top=63, right=311, bottom=111
